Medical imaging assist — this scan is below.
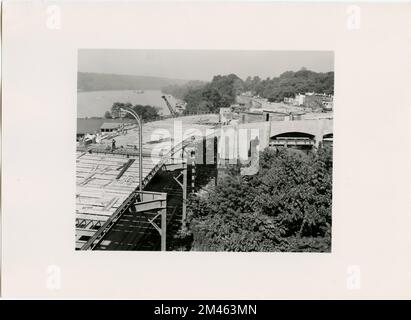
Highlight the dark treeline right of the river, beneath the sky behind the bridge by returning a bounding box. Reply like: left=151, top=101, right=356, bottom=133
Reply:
left=162, top=68, right=334, bottom=113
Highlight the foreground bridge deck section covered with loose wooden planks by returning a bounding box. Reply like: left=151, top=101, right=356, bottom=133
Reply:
left=76, top=153, right=160, bottom=248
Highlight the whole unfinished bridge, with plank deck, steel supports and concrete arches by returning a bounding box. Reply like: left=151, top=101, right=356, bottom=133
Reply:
left=76, top=115, right=333, bottom=250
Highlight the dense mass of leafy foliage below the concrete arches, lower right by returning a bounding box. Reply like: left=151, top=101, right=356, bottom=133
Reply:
left=188, top=149, right=332, bottom=251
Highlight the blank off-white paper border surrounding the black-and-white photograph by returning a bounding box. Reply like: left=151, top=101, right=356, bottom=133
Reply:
left=1, top=1, right=411, bottom=299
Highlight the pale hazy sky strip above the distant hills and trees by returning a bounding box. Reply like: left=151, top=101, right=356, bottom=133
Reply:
left=78, top=49, right=334, bottom=81
